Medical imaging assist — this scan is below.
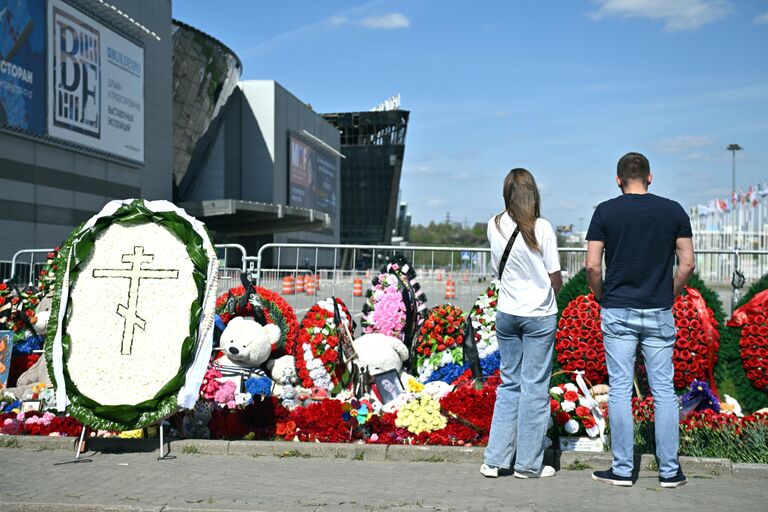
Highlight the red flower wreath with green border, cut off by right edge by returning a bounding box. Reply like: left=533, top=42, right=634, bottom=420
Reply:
left=720, top=275, right=768, bottom=411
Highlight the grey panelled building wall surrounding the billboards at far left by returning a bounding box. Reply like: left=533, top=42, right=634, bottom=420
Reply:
left=0, top=0, right=171, bottom=260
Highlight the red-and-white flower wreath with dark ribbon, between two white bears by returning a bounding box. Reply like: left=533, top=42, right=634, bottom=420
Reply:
left=295, top=297, right=355, bottom=395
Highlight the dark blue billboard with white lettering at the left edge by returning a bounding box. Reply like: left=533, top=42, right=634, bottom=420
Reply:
left=0, top=0, right=45, bottom=135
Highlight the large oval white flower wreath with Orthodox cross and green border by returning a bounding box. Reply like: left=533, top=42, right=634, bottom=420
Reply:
left=45, top=200, right=217, bottom=431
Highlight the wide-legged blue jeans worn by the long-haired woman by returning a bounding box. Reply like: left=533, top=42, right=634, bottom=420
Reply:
left=485, top=311, right=557, bottom=473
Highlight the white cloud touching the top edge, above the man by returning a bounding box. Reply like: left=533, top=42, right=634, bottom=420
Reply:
left=589, top=0, right=732, bottom=32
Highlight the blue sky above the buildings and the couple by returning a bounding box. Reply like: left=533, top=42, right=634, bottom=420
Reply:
left=173, top=0, right=768, bottom=229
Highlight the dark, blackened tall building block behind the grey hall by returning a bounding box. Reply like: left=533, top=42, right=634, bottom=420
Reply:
left=323, top=110, right=409, bottom=244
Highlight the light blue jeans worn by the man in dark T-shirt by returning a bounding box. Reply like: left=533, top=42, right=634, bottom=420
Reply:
left=602, top=308, right=680, bottom=478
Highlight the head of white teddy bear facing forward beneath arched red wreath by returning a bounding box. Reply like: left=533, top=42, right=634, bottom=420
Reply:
left=217, top=316, right=282, bottom=368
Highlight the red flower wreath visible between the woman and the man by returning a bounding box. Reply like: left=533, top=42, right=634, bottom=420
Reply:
left=555, top=294, right=608, bottom=384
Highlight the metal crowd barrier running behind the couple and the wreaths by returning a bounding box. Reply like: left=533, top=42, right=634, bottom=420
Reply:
left=255, top=244, right=768, bottom=314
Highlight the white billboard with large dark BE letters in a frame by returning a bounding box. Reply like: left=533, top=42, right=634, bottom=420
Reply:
left=47, top=0, right=144, bottom=161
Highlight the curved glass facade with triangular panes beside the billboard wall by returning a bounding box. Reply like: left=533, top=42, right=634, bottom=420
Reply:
left=173, top=20, right=243, bottom=190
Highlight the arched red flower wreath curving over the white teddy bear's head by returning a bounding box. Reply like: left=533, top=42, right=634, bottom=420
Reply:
left=216, top=286, right=299, bottom=357
